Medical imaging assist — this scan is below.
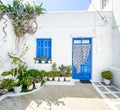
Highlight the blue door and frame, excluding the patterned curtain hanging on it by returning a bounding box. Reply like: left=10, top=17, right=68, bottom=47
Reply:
left=72, top=38, right=92, bottom=80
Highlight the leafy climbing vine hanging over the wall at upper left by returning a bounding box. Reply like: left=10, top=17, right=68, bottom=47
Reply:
left=0, top=0, right=45, bottom=38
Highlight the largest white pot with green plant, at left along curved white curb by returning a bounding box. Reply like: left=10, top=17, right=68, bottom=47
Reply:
left=13, top=79, right=23, bottom=93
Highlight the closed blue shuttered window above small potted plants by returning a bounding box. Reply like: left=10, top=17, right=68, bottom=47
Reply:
left=36, top=38, right=52, bottom=62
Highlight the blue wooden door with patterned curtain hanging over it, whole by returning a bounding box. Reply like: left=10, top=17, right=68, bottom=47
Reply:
left=72, top=38, right=92, bottom=80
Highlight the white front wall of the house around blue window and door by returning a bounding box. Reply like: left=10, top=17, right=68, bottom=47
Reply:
left=0, top=12, right=112, bottom=81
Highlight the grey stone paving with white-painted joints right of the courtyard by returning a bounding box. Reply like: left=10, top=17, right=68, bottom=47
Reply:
left=93, top=82, right=120, bottom=110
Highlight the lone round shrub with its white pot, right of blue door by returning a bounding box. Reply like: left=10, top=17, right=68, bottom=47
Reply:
left=101, top=70, right=112, bottom=85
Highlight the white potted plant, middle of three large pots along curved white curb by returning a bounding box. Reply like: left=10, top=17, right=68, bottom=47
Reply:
left=24, top=76, right=34, bottom=90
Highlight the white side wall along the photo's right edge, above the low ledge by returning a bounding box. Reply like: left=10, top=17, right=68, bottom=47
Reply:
left=113, top=0, right=120, bottom=68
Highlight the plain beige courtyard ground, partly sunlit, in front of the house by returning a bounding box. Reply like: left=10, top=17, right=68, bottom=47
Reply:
left=0, top=82, right=119, bottom=110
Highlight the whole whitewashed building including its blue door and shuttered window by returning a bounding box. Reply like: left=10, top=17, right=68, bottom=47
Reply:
left=0, top=0, right=120, bottom=86
